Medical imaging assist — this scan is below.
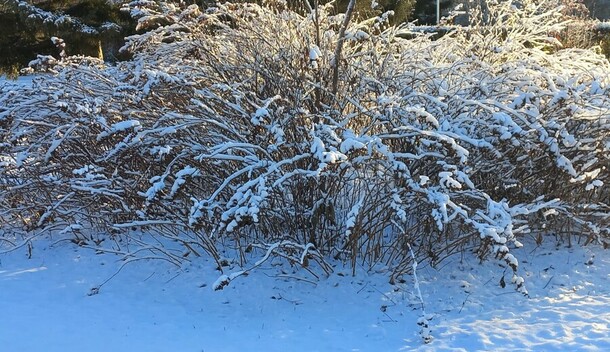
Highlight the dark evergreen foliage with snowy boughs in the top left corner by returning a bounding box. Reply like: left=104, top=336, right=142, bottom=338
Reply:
left=0, top=0, right=135, bottom=74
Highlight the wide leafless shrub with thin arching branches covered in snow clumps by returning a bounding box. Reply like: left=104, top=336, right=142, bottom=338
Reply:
left=0, top=1, right=610, bottom=293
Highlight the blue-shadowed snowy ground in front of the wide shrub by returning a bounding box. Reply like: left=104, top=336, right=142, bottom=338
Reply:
left=0, top=239, right=610, bottom=352
